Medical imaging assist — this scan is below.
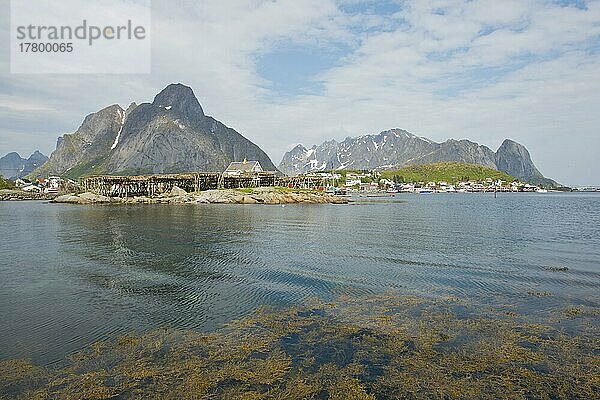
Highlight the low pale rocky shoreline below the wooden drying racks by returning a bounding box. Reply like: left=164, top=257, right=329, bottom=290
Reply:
left=51, top=187, right=348, bottom=204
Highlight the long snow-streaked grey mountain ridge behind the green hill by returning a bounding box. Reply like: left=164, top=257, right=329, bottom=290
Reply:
left=279, top=129, right=557, bottom=186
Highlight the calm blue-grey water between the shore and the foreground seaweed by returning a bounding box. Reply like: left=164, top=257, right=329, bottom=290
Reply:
left=0, top=194, right=600, bottom=364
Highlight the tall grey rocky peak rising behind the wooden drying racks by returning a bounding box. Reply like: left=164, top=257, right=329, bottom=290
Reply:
left=32, top=84, right=276, bottom=177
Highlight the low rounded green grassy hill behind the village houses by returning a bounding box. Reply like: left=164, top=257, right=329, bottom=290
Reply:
left=381, top=162, right=517, bottom=183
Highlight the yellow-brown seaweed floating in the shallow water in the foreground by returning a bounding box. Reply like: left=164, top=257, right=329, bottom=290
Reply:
left=0, top=294, right=600, bottom=399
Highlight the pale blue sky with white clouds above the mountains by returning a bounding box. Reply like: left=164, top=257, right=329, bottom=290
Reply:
left=0, top=0, right=600, bottom=185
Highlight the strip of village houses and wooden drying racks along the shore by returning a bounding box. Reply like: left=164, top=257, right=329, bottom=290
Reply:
left=4, top=160, right=547, bottom=197
